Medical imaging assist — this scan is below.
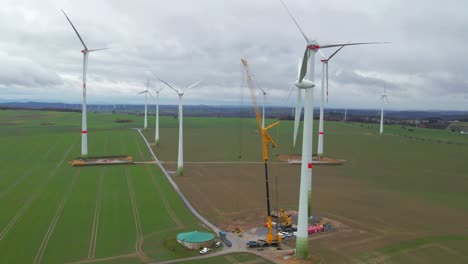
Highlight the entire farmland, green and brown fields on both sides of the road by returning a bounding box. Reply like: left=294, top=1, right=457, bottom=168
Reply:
left=0, top=108, right=468, bottom=263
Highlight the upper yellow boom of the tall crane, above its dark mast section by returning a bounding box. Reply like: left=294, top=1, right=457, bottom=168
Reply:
left=241, top=59, right=279, bottom=162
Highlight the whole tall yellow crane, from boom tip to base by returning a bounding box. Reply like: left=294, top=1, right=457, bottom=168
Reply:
left=241, top=59, right=282, bottom=246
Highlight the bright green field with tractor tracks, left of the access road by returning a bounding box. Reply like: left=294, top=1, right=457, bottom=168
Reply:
left=0, top=111, right=219, bottom=263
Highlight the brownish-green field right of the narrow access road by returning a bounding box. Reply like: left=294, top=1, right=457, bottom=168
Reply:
left=140, top=113, right=468, bottom=263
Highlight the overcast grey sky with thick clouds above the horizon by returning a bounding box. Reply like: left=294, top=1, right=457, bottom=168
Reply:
left=0, top=0, right=468, bottom=111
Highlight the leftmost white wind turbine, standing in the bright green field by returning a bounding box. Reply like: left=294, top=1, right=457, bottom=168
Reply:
left=62, top=9, right=106, bottom=158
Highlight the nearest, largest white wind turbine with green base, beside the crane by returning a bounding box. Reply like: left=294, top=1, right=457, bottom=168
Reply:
left=280, top=0, right=386, bottom=259
